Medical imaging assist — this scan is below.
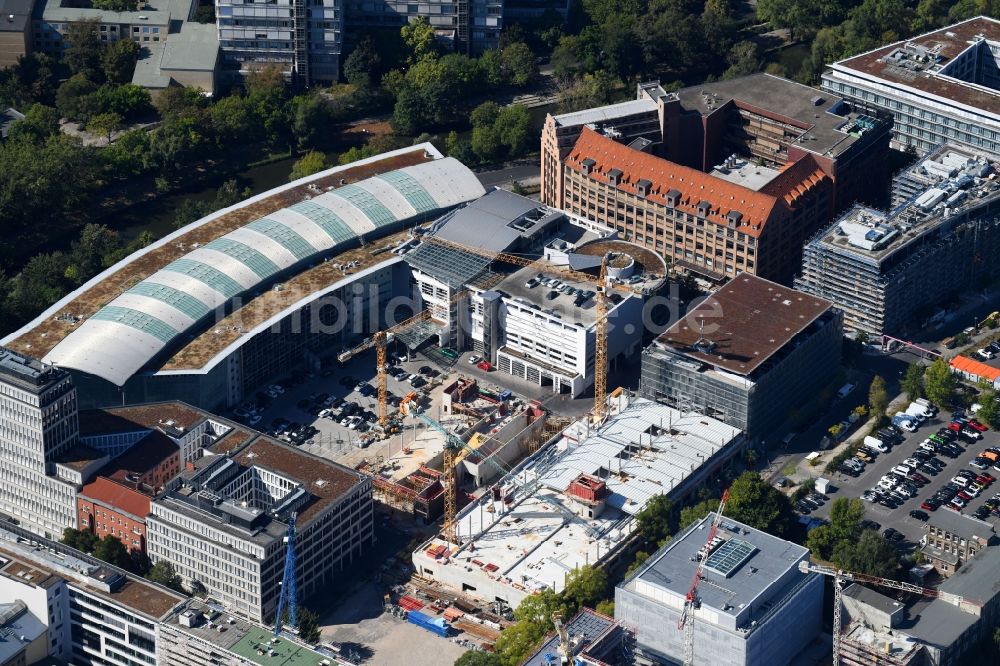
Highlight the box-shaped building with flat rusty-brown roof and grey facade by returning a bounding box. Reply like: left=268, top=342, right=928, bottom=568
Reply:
left=639, top=273, right=843, bottom=438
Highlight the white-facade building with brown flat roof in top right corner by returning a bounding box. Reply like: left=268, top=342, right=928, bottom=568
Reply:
left=822, top=16, right=1000, bottom=154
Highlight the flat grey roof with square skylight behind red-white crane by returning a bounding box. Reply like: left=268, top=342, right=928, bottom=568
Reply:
left=624, top=512, right=809, bottom=618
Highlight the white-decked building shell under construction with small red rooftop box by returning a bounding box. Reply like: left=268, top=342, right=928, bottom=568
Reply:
left=413, top=391, right=746, bottom=607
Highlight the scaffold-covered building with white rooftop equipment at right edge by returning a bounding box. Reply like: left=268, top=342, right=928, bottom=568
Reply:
left=795, top=144, right=1000, bottom=335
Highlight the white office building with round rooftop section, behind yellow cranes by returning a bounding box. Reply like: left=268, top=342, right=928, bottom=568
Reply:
left=401, top=190, right=666, bottom=396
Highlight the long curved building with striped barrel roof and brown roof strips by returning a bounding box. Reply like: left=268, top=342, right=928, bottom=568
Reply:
left=3, top=144, right=484, bottom=409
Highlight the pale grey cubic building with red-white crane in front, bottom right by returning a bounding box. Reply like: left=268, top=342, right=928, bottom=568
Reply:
left=615, top=513, right=823, bottom=666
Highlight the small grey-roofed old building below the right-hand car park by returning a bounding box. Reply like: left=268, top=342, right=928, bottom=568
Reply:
left=920, top=511, right=1000, bottom=578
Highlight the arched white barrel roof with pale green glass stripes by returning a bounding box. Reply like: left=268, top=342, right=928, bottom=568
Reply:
left=44, top=158, right=484, bottom=386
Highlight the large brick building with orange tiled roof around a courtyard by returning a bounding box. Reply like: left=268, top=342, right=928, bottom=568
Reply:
left=541, top=74, right=890, bottom=282
